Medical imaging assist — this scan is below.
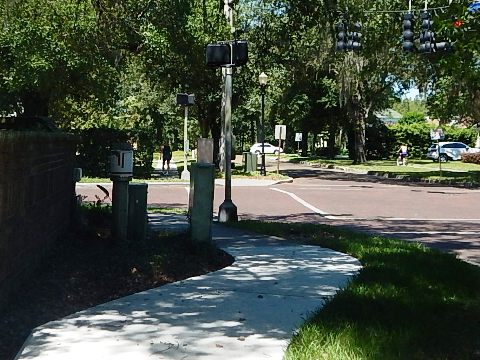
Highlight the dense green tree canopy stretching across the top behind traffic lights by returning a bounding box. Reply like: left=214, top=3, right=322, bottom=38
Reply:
left=0, top=0, right=480, bottom=162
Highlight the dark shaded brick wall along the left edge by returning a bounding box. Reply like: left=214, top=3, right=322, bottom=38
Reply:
left=0, top=131, right=75, bottom=306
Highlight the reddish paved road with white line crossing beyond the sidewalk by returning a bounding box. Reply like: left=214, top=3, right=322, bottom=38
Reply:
left=77, top=159, right=480, bottom=265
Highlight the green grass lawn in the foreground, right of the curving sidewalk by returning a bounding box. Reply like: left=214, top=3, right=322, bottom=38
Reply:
left=229, top=221, right=480, bottom=360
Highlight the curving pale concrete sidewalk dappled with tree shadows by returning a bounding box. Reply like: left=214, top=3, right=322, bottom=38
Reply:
left=17, top=214, right=360, bottom=360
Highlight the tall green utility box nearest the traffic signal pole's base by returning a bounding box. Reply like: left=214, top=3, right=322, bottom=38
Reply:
left=188, top=163, right=215, bottom=243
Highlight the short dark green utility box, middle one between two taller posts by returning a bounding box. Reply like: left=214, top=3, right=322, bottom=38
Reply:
left=127, top=183, right=148, bottom=242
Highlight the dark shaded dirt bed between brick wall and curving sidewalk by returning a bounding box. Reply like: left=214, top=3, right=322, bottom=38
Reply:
left=0, top=228, right=233, bottom=360
